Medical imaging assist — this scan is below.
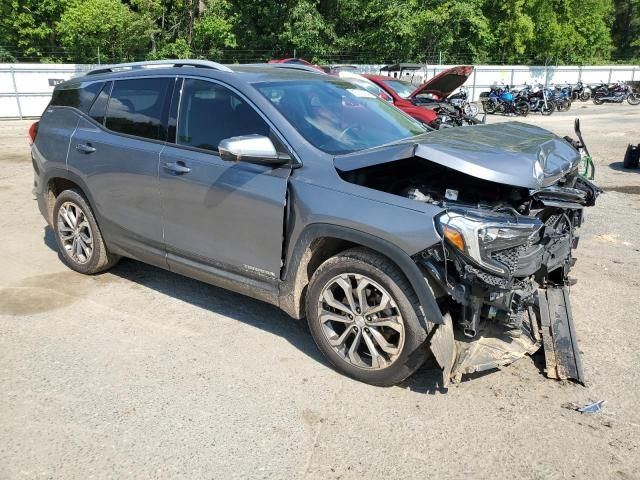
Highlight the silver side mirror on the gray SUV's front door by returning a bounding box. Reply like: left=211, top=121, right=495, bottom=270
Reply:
left=218, top=135, right=291, bottom=166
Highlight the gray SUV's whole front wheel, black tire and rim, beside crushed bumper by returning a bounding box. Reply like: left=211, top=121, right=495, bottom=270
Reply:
left=306, top=248, right=428, bottom=386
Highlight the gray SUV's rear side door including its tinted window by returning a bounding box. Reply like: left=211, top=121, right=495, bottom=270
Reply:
left=69, top=77, right=175, bottom=265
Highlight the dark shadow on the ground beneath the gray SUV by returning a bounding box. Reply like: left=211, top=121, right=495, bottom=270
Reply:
left=43, top=226, right=447, bottom=394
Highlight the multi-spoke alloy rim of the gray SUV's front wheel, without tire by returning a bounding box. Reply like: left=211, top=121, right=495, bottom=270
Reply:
left=318, top=273, right=405, bottom=370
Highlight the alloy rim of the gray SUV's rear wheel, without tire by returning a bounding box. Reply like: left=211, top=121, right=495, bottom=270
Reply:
left=57, top=202, right=93, bottom=264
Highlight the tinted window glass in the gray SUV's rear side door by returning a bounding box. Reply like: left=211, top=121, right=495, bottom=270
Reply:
left=105, top=78, right=171, bottom=140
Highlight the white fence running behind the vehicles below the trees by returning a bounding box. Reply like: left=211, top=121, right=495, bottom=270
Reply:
left=0, top=63, right=640, bottom=118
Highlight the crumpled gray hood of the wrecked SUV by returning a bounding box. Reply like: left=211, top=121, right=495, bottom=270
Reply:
left=335, top=122, right=580, bottom=189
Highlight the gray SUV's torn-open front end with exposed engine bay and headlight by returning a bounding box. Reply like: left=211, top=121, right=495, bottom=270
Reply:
left=340, top=152, right=600, bottom=384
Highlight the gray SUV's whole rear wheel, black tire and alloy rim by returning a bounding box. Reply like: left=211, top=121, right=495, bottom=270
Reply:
left=53, top=190, right=118, bottom=275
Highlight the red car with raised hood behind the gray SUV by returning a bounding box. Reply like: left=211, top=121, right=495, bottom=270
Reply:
left=363, top=65, right=473, bottom=125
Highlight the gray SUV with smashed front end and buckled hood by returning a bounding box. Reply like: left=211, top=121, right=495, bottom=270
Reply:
left=32, top=60, right=598, bottom=385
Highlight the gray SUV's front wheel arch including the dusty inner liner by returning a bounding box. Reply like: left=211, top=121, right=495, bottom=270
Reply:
left=279, top=223, right=444, bottom=329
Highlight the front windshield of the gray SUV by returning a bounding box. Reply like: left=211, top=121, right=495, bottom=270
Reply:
left=255, top=80, right=425, bottom=155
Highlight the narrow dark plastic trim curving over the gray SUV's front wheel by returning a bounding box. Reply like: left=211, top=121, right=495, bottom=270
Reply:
left=280, top=223, right=444, bottom=330
